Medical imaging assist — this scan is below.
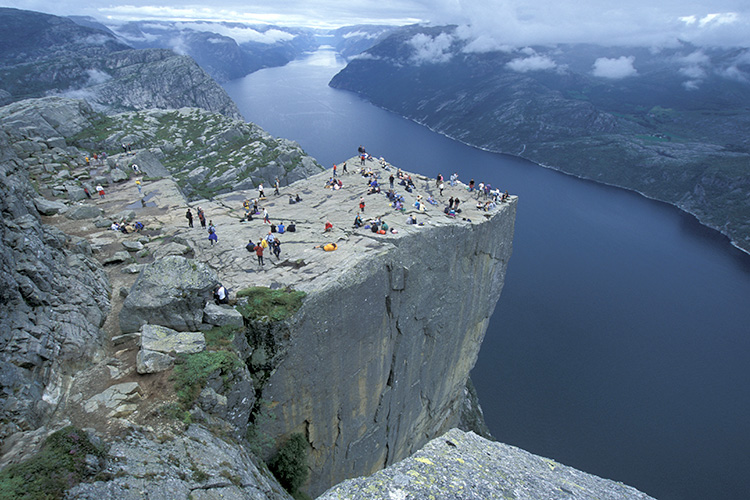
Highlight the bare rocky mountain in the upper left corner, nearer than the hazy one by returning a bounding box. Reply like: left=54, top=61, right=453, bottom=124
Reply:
left=0, top=8, right=241, bottom=118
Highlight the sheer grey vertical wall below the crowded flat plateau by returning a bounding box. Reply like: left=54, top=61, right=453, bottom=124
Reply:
left=263, top=199, right=516, bottom=494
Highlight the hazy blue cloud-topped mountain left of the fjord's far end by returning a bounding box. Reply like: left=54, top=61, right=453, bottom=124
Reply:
left=100, top=21, right=318, bottom=82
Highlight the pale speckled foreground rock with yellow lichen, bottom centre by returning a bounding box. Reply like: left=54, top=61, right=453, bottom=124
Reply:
left=318, top=429, right=651, bottom=500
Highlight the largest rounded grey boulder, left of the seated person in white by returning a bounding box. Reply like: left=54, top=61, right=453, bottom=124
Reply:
left=120, top=256, right=218, bottom=333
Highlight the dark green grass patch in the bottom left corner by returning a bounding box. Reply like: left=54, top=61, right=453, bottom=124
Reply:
left=0, top=427, right=105, bottom=500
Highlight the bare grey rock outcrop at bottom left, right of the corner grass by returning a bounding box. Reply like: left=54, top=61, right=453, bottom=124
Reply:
left=66, top=425, right=292, bottom=500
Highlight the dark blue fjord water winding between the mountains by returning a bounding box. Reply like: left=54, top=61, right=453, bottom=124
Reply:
left=225, top=50, right=750, bottom=500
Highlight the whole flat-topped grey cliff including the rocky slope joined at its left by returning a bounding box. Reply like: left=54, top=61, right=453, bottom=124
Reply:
left=0, top=79, right=648, bottom=500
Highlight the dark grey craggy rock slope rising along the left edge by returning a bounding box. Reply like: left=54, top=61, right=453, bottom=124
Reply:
left=0, top=96, right=109, bottom=439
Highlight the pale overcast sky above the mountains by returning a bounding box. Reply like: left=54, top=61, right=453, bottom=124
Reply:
left=0, top=0, right=750, bottom=47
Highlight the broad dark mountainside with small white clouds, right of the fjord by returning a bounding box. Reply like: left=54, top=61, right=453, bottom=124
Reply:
left=330, top=26, right=750, bottom=251
